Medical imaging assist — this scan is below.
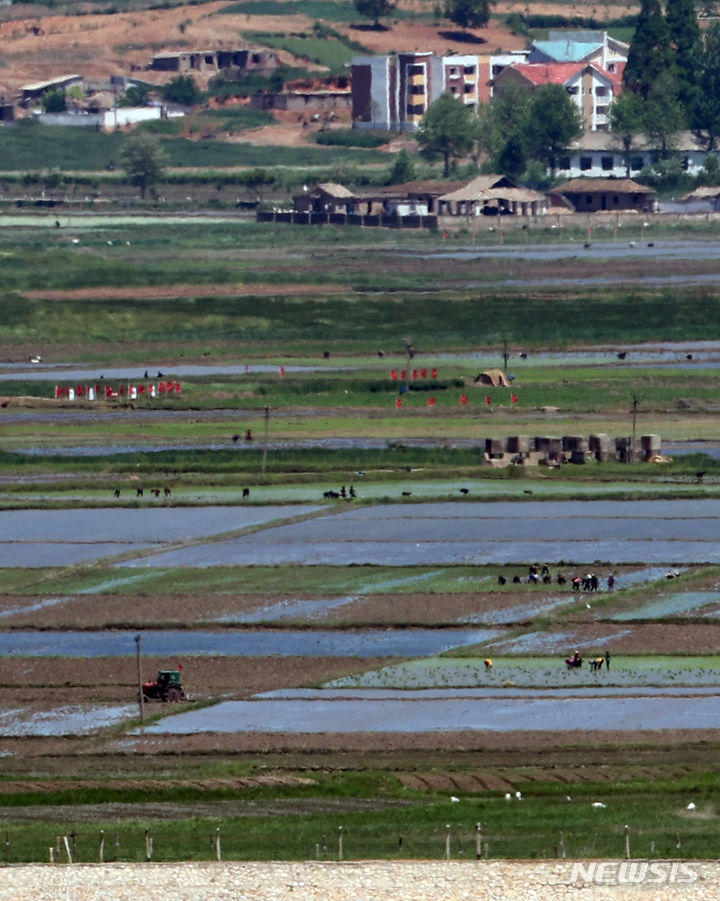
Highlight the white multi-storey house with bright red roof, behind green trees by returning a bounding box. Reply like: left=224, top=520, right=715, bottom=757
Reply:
left=495, top=63, right=624, bottom=131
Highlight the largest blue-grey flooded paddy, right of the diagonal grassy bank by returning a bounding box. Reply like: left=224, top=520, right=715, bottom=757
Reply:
left=124, top=500, right=720, bottom=567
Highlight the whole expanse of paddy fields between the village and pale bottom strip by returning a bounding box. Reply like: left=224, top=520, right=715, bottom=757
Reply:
left=0, top=216, right=720, bottom=862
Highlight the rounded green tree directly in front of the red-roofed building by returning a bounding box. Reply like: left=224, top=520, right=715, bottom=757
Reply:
left=525, top=84, right=582, bottom=171
